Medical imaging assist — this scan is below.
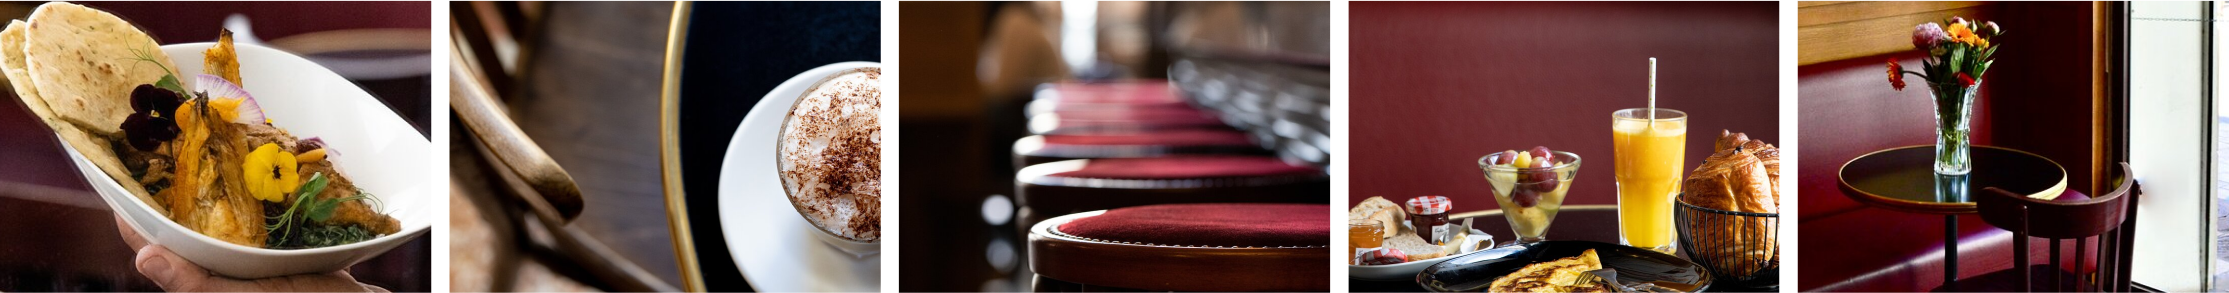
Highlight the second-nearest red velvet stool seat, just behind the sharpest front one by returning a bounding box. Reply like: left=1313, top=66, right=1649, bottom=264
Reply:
left=1014, top=157, right=1340, bottom=235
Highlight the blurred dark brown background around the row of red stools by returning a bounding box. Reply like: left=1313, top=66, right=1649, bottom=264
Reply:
left=885, top=0, right=1337, bottom=293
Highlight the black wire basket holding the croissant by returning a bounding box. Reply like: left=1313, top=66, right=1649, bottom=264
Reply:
left=1674, top=201, right=1781, bottom=289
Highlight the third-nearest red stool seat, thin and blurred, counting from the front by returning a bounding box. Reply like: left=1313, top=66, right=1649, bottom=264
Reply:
left=1014, top=130, right=1271, bottom=168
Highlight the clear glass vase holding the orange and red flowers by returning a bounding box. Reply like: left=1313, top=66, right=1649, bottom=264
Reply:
left=1928, top=81, right=1982, bottom=174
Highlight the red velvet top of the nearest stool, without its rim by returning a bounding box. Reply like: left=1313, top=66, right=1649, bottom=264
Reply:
left=1059, top=204, right=1340, bottom=246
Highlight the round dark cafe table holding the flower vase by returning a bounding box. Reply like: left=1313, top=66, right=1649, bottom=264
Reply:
left=1839, top=145, right=2066, bottom=291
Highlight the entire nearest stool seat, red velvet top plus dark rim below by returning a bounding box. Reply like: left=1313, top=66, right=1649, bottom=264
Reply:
left=1030, top=204, right=1340, bottom=291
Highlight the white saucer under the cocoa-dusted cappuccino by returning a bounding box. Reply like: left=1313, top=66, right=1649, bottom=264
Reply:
left=718, top=63, right=883, bottom=293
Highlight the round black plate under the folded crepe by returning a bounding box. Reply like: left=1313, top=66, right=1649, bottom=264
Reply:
left=1415, top=242, right=1712, bottom=293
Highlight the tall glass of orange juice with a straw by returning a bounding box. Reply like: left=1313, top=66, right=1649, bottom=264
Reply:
left=1609, top=107, right=1687, bottom=253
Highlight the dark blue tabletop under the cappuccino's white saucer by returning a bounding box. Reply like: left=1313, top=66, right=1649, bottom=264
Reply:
left=673, top=0, right=883, bottom=293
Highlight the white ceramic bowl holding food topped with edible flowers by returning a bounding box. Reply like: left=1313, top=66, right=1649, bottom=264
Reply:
left=62, top=42, right=432, bottom=280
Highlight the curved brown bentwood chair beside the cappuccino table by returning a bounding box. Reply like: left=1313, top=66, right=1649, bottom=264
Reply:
left=448, top=0, right=680, bottom=293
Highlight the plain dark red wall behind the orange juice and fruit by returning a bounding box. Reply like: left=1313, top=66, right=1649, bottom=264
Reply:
left=1346, top=0, right=1783, bottom=210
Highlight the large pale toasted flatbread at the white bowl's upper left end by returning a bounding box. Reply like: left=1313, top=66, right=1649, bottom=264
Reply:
left=25, top=2, right=176, bottom=134
